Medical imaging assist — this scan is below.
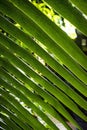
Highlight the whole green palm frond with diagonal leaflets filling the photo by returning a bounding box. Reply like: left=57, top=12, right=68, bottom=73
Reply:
left=0, top=0, right=87, bottom=130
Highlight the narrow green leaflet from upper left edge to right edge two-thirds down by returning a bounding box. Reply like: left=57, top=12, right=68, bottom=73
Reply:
left=0, top=17, right=87, bottom=97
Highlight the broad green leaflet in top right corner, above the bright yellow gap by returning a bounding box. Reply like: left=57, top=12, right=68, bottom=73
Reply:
left=45, top=0, right=87, bottom=35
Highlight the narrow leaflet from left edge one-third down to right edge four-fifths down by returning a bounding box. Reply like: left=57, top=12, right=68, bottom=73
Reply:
left=2, top=33, right=87, bottom=110
